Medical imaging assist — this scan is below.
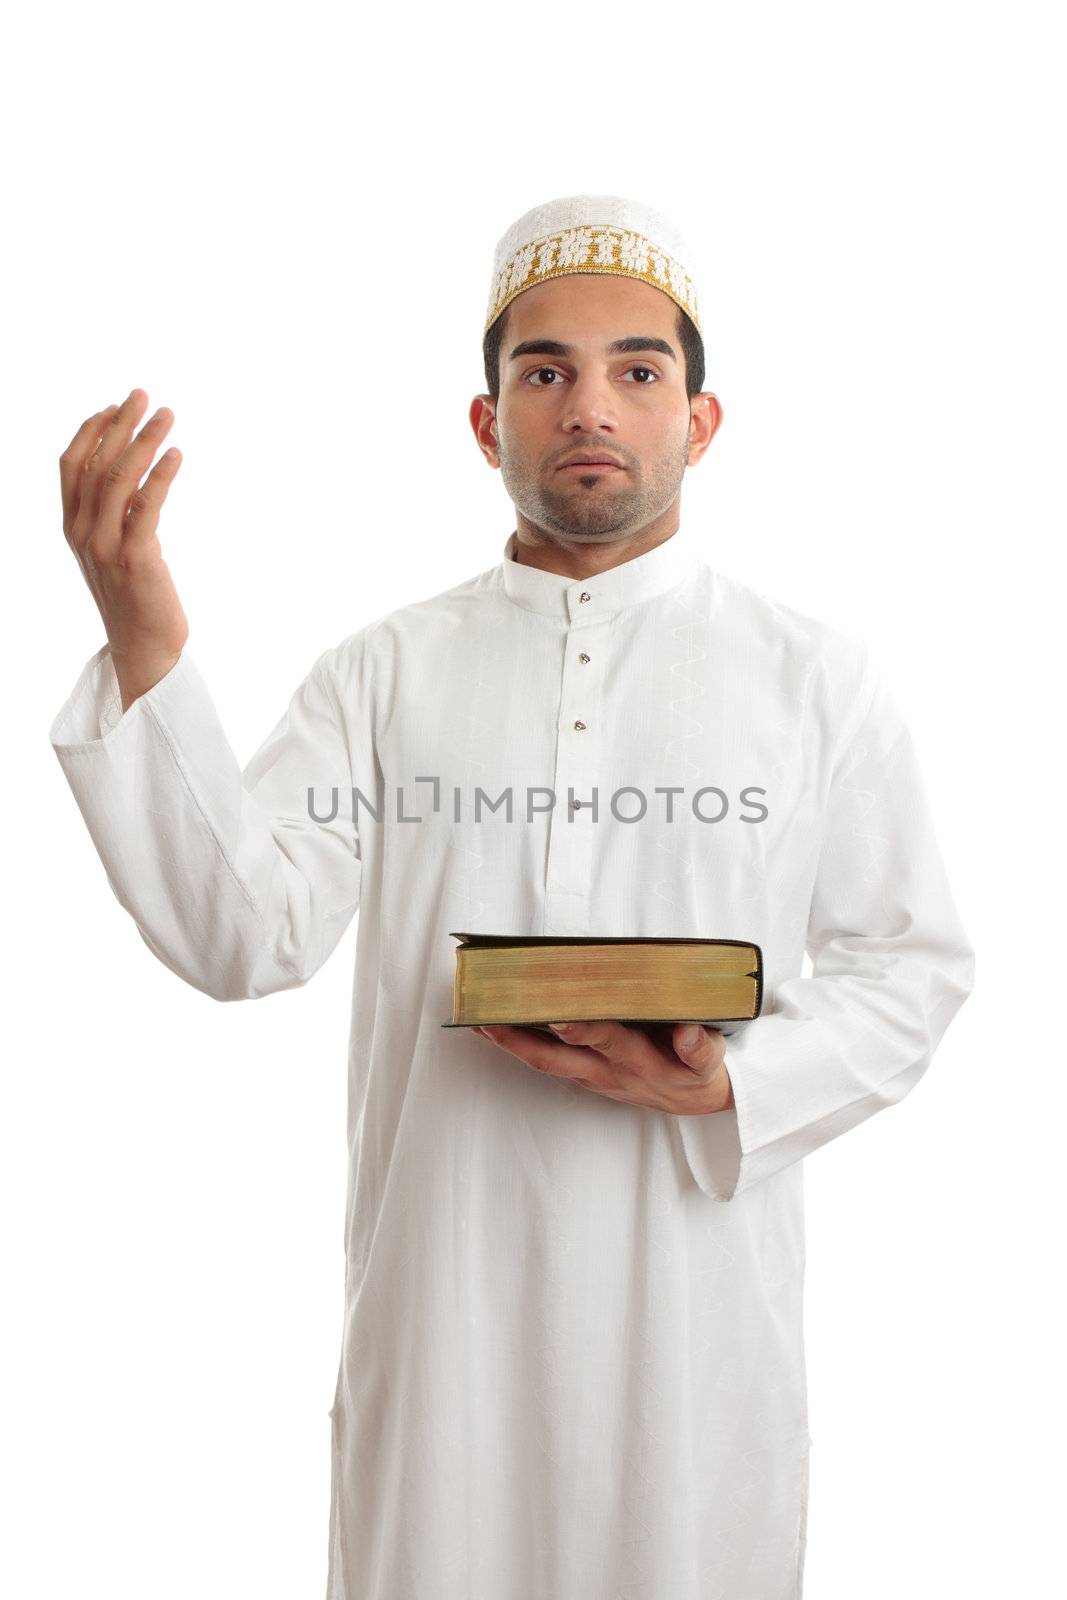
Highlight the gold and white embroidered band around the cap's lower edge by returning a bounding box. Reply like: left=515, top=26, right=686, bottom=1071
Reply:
left=482, top=226, right=702, bottom=333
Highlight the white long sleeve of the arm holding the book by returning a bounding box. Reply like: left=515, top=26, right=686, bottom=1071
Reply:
left=678, top=661, right=974, bottom=1200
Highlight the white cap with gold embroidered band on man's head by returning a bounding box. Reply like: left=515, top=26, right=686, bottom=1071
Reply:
left=483, top=195, right=702, bottom=334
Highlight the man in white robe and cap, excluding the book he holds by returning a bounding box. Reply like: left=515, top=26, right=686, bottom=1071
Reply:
left=51, top=195, right=973, bottom=1600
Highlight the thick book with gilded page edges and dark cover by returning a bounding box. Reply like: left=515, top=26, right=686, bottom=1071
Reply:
left=442, top=933, right=763, bottom=1038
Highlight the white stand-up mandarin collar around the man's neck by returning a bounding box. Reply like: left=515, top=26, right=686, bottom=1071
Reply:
left=501, top=528, right=697, bottom=622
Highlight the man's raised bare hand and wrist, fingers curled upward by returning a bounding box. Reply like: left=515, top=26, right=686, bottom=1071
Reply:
left=59, top=389, right=189, bottom=710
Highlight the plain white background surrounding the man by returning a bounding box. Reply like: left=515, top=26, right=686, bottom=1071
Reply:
left=0, top=0, right=1067, bottom=1600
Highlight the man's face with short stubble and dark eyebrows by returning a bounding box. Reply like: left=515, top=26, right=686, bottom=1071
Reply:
left=493, top=274, right=691, bottom=544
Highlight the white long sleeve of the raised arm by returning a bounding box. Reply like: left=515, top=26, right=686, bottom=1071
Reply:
left=50, top=645, right=362, bottom=1000
